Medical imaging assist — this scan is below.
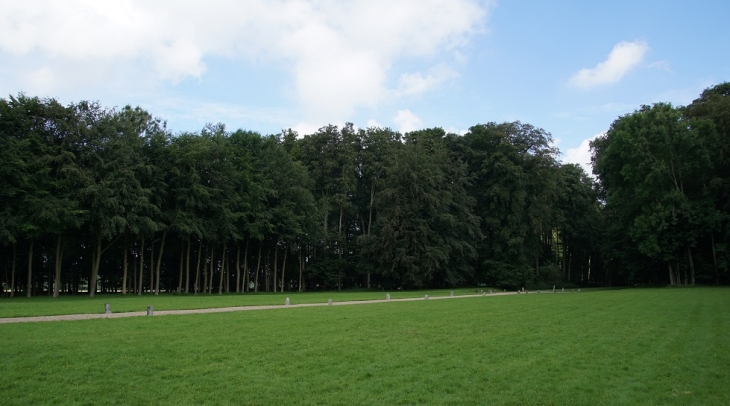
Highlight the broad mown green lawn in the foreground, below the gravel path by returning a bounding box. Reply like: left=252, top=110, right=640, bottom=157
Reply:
left=0, top=288, right=730, bottom=405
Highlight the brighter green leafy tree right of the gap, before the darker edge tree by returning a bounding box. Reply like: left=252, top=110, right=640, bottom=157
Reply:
left=591, top=97, right=724, bottom=284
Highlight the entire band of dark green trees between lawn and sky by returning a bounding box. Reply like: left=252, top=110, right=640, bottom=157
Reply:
left=0, top=83, right=730, bottom=296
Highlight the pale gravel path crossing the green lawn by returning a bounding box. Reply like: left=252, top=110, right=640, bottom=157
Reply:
left=0, top=292, right=517, bottom=324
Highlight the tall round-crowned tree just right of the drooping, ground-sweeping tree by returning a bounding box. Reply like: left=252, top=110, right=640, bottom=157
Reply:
left=449, top=122, right=558, bottom=287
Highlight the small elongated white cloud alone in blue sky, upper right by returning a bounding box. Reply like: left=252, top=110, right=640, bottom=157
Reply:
left=570, top=41, right=649, bottom=89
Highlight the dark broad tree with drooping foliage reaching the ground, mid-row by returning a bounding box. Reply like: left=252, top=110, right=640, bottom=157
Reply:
left=369, top=129, right=481, bottom=287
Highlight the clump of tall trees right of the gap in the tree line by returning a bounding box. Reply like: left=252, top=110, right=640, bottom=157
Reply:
left=591, top=83, right=730, bottom=285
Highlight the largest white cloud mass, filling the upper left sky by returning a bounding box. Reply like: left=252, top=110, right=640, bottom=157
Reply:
left=0, top=0, right=494, bottom=122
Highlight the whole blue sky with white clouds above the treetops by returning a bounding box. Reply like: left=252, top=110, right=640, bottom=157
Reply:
left=0, top=0, right=730, bottom=173
